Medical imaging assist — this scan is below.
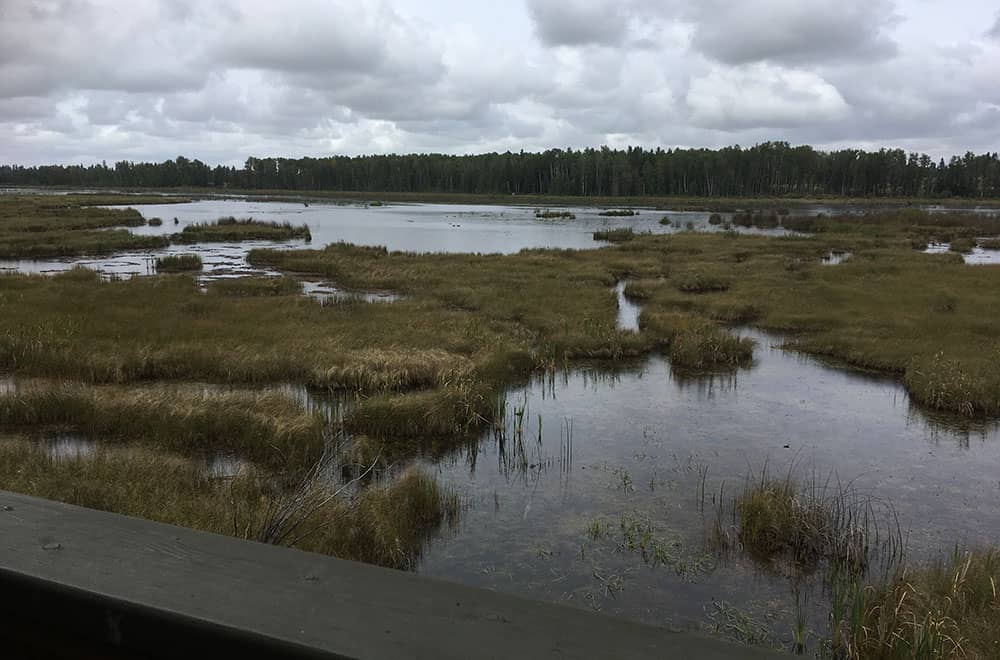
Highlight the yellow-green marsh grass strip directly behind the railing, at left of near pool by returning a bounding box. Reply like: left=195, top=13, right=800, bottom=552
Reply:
left=0, top=438, right=461, bottom=569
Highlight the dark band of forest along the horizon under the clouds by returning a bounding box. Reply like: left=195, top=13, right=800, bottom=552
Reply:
left=0, top=142, right=1000, bottom=198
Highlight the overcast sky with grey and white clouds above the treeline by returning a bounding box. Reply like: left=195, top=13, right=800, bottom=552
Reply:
left=0, top=0, right=1000, bottom=164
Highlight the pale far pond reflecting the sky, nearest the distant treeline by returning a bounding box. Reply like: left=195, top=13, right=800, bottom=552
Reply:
left=0, top=200, right=788, bottom=284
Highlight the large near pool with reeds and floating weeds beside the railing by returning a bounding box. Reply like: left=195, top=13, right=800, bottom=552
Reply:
left=419, top=330, right=1000, bottom=630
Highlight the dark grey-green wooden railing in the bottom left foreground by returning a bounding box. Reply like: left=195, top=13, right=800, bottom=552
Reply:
left=0, top=491, right=775, bottom=660
